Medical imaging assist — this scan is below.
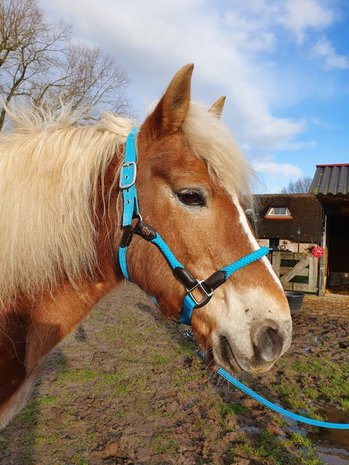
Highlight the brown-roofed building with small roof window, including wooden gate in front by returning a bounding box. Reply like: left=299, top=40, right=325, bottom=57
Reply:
left=250, top=194, right=322, bottom=293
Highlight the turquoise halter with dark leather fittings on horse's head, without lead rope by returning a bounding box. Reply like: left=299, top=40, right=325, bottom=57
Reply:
left=118, top=128, right=269, bottom=325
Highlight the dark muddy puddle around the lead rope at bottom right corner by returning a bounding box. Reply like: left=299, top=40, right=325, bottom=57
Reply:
left=307, top=408, right=349, bottom=465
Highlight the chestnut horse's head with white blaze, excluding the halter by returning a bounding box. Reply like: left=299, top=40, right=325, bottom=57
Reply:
left=117, top=65, right=292, bottom=373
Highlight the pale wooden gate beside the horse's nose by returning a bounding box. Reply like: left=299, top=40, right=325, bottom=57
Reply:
left=271, top=250, right=318, bottom=293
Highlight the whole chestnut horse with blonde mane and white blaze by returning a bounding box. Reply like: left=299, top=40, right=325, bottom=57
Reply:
left=0, top=65, right=292, bottom=426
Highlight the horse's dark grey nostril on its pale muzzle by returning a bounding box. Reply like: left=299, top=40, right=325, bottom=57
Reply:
left=253, top=326, right=284, bottom=362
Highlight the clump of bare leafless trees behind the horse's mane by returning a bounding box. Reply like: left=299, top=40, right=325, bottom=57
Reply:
left=0, top=0, right=128, bottom=130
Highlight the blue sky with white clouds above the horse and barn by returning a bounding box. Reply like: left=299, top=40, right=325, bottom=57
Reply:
left=41, top=0, right=349, bottom=193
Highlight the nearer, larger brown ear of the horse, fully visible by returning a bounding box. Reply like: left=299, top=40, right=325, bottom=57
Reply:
left=145, top=64, right=194, bottom=136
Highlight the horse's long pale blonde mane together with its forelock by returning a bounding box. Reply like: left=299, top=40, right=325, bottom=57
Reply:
left=0, top=103, right=249, bottom=307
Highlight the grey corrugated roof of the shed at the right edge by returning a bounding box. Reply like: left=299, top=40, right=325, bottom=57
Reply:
left=309, top=163, right=349, bottom=195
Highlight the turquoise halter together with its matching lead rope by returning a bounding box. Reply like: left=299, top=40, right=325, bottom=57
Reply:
left=118, top=128, right=349, bottom=430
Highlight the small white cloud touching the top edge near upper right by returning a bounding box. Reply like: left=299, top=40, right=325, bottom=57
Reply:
left=279, top=0, right=336, bottom=43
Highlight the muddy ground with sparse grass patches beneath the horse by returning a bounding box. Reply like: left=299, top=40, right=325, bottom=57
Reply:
left=0, top=285, right=349, bottom=465
